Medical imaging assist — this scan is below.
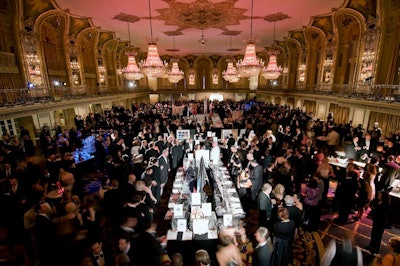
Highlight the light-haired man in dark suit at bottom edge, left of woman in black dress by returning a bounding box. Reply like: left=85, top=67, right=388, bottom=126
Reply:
left=253, top=227, right=274, bottom=266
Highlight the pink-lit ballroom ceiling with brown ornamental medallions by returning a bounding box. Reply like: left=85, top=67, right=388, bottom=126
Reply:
left=56, top=0, right=345, bottom=55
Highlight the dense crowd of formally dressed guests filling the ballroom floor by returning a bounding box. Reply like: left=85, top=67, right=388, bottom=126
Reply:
left=0, top=100, right=400, bottom=265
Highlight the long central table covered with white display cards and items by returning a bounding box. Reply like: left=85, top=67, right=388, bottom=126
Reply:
left=167, top=165, right=245, bottom=263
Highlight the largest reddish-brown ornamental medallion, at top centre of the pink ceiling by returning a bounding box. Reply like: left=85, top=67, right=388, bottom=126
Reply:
left=153, top=0, right=261, bottom=31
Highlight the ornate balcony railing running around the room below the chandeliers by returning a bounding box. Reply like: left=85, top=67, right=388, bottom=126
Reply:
left=0, top=84, right=400, bottom=107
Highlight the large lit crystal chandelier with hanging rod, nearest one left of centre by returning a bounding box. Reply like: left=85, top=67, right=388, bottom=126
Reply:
left=140, top=0, right=166, bottom=78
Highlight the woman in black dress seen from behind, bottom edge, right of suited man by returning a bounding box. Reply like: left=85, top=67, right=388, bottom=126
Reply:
left=271, top=208, right=296, bottom=266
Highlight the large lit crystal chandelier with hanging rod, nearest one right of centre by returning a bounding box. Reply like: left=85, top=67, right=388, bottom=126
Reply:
left=237, top=0, right=264, bottom=77
